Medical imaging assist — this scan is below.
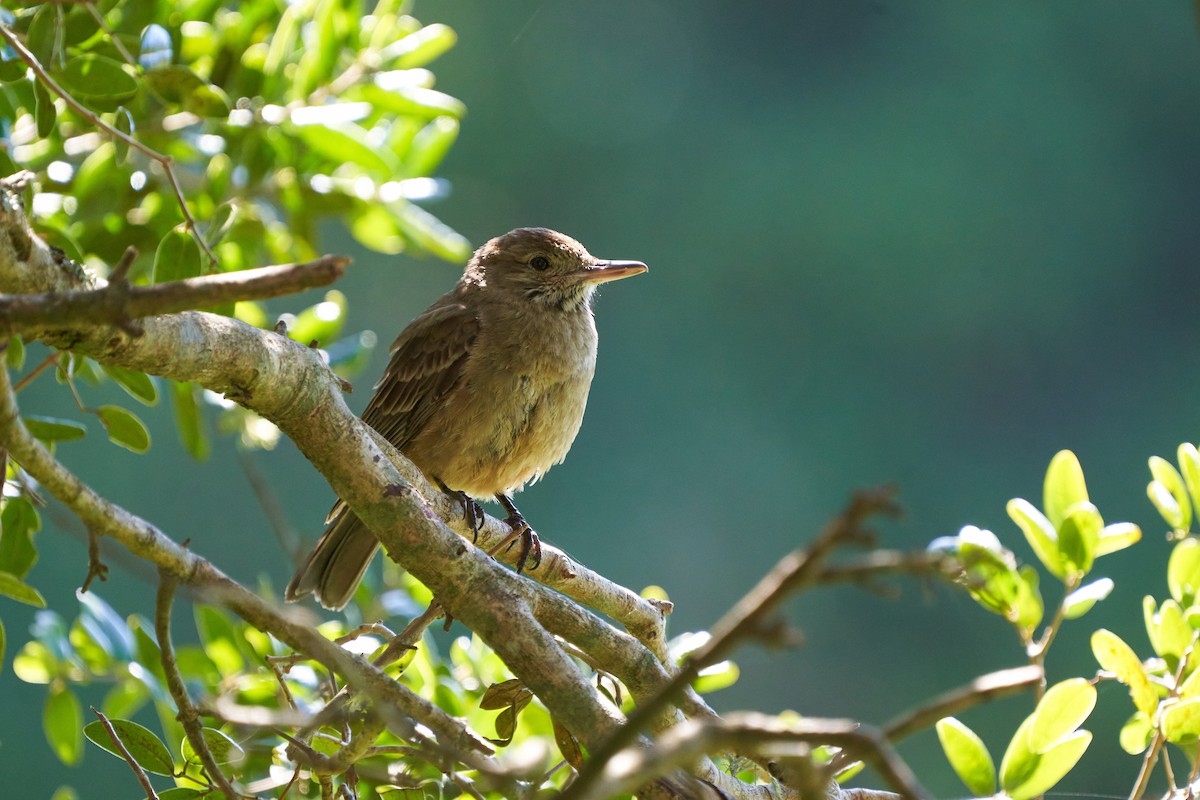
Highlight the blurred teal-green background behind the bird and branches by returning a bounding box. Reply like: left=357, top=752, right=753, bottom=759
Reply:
left=0, top=0, right=1200, bottom=798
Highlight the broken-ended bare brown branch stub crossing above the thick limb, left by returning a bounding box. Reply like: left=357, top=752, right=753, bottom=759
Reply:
left=0, top=255, right=349, bottom=336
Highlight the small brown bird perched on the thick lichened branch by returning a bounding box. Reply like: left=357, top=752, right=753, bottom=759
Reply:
left=284, top=228, right=647, bottom=609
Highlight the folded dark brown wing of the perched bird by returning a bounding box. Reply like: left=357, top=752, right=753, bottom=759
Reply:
left=362, top=300, right=479, bottom=451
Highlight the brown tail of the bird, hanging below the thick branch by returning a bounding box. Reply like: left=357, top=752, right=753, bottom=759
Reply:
left=283, top=501, right=379, bottom=610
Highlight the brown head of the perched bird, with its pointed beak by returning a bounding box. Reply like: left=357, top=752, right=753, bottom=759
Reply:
left=464, top=228, right=647, bottom=311
